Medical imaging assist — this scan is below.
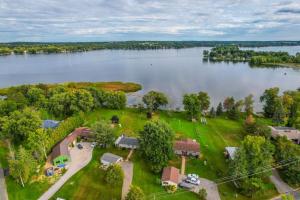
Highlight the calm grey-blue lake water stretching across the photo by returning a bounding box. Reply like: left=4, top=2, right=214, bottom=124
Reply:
left=0, top=46, right=300, bottom=110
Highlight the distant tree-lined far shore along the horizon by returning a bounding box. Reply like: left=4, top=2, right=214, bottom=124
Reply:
left=0, top=41, right=300, bottom=55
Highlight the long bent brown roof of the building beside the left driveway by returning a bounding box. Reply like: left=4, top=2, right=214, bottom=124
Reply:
left=51, top=127, right=90, bottom=159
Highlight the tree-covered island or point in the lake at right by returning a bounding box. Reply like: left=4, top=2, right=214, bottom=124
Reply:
left=203, top=45, right=300, bottom=67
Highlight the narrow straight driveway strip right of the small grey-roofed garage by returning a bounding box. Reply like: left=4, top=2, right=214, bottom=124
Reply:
left=121, top=161, right=133, bottom=199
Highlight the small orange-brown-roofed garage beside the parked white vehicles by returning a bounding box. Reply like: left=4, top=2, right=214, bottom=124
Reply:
left=161, top=167, right=179, bottom=187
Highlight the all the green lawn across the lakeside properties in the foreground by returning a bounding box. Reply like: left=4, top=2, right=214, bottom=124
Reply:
left=0, top=108, right=277, bottom=200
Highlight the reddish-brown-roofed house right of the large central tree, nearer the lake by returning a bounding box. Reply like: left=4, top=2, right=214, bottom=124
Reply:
left=173, top=139, right=200, bottom=157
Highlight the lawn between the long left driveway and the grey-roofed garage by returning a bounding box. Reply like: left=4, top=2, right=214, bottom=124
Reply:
left=52, top=148, right=129, bottom=200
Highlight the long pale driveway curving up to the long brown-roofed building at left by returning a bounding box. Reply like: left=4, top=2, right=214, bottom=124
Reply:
left=39, top=142, right=93, bottom=200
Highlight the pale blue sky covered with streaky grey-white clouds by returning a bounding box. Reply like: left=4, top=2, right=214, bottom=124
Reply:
left=0, top=0, right=300, bottom=42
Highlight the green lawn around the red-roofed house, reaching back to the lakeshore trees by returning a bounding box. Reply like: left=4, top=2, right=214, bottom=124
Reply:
left=82, top=109, right=277, bottom=200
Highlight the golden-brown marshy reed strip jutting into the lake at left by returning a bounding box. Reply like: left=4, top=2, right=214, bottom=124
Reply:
left=0, top=82, right=142, bottom=95
